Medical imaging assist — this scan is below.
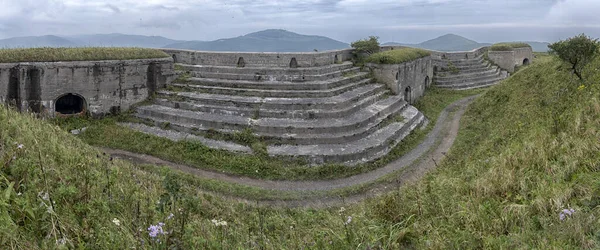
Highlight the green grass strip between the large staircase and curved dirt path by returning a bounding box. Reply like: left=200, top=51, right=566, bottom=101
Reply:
left=54, top=88, right=481, bottom=180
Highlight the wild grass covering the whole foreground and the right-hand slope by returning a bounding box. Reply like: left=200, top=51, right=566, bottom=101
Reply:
left=0, top=47, right=600, bottom=249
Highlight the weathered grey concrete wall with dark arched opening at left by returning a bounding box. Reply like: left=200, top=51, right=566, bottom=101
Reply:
left=0, top=58, right=174, bottom=117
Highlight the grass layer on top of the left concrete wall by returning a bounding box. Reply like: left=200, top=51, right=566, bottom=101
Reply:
left=0, top=47, right=169, bottom=63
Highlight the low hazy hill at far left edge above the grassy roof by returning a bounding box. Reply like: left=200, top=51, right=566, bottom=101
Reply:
left=0, top=36, right=77, bottom=48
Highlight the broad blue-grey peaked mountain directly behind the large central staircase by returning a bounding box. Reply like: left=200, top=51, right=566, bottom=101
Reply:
left=164, top=29, right=350, bottom=52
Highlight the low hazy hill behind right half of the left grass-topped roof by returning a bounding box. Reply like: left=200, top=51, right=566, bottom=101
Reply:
left=67, top=33, right=182, bottom=48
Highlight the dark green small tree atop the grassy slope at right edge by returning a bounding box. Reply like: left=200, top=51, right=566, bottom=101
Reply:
left=548, top=34, right=600, bottom=80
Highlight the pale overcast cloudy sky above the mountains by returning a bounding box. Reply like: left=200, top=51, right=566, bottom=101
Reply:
left=0, top=0, right=600, bottom=42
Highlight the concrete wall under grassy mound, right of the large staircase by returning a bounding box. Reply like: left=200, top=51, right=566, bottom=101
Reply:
left=365, top=57, right=433, bottom=103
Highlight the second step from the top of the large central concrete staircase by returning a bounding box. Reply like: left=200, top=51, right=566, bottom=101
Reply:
left=178, top=72, right=369, bottom=90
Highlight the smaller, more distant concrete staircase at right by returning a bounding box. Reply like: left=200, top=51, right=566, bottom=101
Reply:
left=434, top=56, right=508, bottom=90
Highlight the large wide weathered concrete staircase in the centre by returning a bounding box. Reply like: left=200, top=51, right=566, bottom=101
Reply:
left=128, top=62, right=425, bottom=165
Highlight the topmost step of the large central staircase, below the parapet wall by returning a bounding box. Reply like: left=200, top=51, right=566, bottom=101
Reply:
left=176, top=62, right=353, bottom=76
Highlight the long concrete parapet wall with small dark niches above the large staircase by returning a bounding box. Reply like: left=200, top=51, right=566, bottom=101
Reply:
left=163, top=49, right=352, bottom=67
